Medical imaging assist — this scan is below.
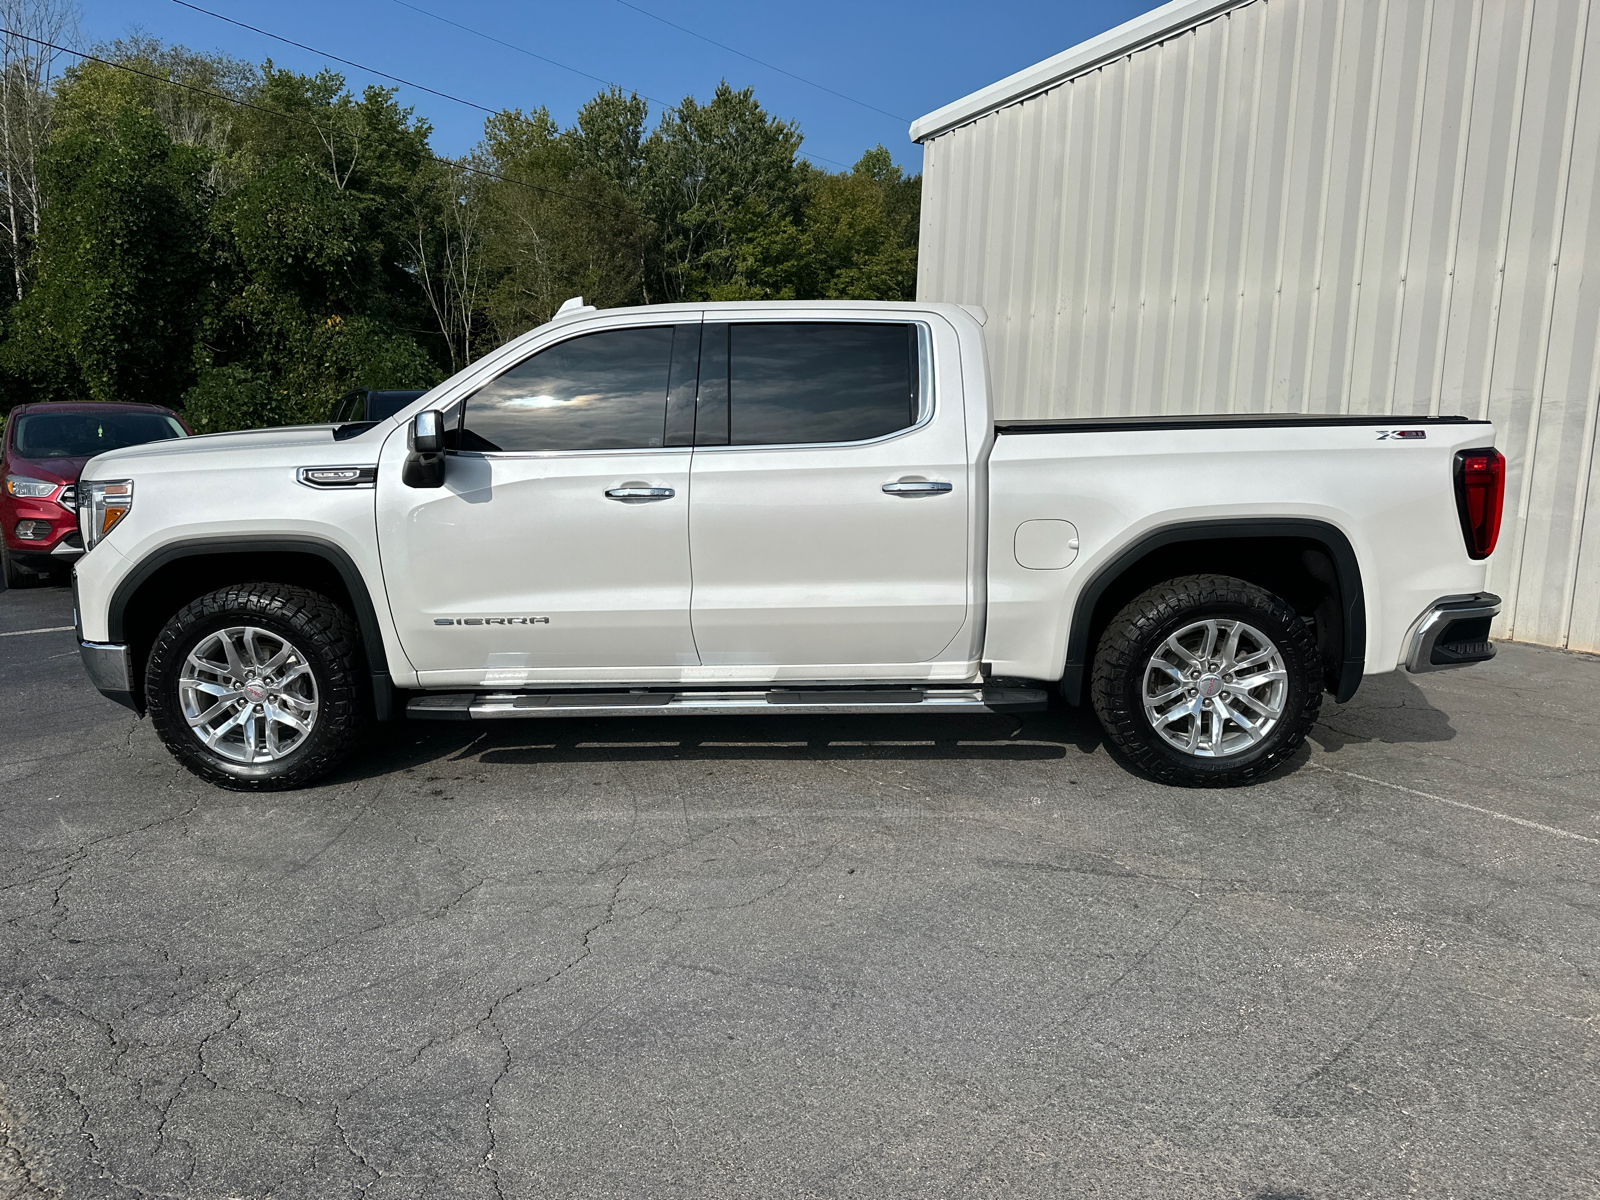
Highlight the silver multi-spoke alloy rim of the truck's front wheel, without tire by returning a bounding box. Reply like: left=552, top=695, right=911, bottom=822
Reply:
left=178, top=626, right=317, bottom=763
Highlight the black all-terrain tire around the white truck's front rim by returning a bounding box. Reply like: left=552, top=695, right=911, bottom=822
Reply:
left=144, top=582, right=368, bottom=792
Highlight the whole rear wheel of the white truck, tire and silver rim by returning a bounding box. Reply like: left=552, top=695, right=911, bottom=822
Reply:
left=1093, top=574, right=1322, bottom=787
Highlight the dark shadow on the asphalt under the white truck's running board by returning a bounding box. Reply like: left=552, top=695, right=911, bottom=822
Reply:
left=339, top=701, right=1102, bottom=781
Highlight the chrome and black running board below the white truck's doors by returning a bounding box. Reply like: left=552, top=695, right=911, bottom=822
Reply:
left=405, top=688, right=1050, bottom=722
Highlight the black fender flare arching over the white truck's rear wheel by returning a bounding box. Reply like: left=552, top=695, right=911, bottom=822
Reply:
left=1061, top=517, right=1366, bottom=704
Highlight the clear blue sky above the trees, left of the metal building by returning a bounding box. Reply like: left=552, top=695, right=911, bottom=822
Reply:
left=80, top=0, right=1155, bottom=171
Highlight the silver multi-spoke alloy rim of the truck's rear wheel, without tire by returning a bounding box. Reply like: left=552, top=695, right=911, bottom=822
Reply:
left=1142, top=619, right=1290, bottom=758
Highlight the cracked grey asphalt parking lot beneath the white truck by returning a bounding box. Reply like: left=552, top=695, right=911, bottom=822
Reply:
left=0, top=589, right=1600, bottom=1200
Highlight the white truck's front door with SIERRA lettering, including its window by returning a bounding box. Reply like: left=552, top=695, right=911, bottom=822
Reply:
left=378, top=323, right=699, bottom=686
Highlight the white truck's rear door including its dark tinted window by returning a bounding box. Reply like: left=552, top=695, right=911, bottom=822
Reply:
left=690, top=318, right=970, bottom=678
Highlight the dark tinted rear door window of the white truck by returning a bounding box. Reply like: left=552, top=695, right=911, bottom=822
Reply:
left=728, top=322, right=917, bottom=446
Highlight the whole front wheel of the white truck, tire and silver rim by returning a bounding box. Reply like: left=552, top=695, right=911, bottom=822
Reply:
left=144, top=584, right=365, bottom=790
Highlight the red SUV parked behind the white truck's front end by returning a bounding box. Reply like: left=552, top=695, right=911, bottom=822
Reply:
left=0, top=403, right=189, bottom=587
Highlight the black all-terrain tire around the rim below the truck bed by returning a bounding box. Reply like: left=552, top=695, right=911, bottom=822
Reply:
left=1091, top=574, right=1323, bottom=787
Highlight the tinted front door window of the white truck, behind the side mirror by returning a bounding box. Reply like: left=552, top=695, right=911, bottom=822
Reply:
left=461, top=326, right=672, bottom=450
